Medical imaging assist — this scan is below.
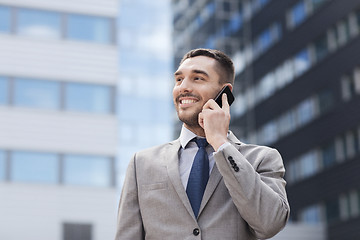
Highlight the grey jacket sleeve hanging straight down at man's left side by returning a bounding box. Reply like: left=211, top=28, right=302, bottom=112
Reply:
left=115, top=156, right=144, bottom=240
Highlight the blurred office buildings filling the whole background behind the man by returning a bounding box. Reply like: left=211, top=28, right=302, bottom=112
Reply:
left=0, top=0, right=360, bottom=240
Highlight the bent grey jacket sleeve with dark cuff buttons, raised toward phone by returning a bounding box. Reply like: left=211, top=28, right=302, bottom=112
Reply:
left=214, top=144, right=290, bottom=239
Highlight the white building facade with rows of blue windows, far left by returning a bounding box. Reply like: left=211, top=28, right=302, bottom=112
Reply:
left=0, top=0, right=118, bottom=240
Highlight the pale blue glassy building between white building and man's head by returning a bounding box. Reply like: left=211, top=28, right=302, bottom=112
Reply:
left=118, top=0, right=174, bottom=187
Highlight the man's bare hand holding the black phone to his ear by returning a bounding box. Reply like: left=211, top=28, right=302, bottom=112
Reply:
left=198, top=93, right=230, bottom=151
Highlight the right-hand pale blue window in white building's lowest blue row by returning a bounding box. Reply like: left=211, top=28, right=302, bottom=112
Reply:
left=64, top=155, right=112, bottom=187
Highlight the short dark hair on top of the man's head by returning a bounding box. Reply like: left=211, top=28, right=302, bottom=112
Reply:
left=180, top=48, right=235, bottom=85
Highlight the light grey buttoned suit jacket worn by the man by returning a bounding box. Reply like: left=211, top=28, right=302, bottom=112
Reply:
left=115, top=133, right=290, bottom=240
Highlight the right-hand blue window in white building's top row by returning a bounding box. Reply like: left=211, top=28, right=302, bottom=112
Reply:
left=67, top=14, right=112, bottom=43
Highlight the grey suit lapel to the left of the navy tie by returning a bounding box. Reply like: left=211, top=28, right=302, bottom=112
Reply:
left=165, top=140, right=194, bottom=216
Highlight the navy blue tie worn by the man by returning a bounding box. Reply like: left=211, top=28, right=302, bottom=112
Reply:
left=186, top=138, right=209, bottom=217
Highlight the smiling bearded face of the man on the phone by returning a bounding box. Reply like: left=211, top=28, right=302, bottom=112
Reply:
left=173, top=56, right=223, bottom=128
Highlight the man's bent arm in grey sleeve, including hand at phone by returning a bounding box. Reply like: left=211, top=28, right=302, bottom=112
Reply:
left=199, top=95, right=289, bottom=238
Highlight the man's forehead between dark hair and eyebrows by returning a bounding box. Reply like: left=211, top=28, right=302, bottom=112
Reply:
left=175, top=56, right=219, bottom=76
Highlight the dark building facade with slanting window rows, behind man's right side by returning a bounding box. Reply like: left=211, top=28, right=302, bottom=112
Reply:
left=172, top=0, right=360, bottom=239
